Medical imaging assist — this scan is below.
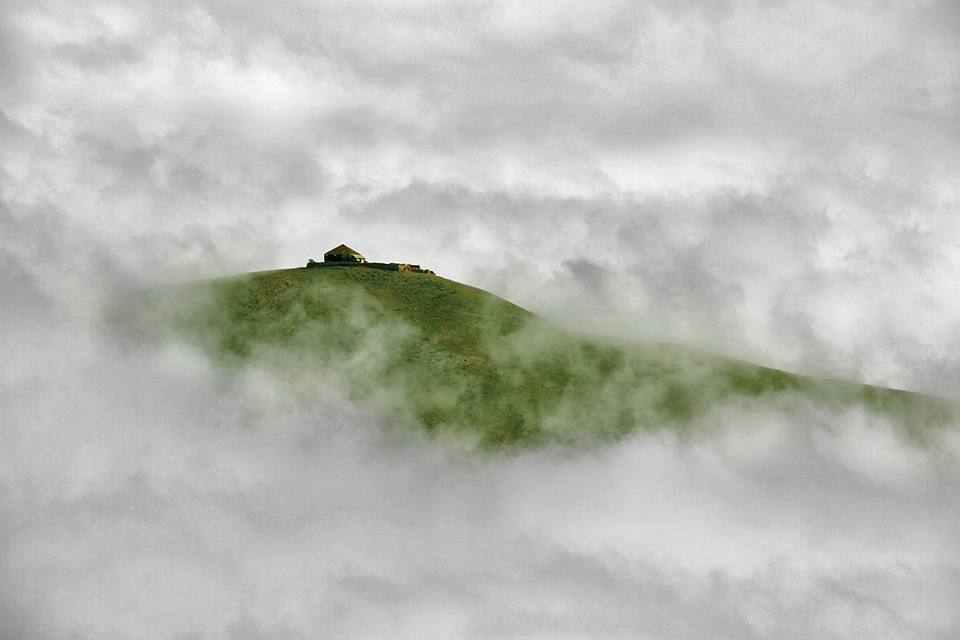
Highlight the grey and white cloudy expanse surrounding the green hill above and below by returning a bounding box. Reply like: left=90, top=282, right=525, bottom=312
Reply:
left=0, top=0, right=960, bottom=640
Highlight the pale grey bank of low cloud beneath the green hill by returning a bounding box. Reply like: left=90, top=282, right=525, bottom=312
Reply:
left=0, top=291, right=960, bottom=638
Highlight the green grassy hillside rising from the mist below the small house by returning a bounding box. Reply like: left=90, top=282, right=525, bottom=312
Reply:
left=131, top=267, right=955, bottom=448
